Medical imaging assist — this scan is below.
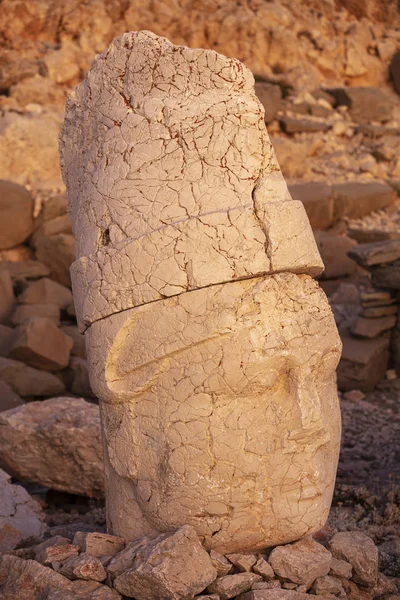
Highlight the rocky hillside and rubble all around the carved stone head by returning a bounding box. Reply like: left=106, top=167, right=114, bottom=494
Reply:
left=0, top=0, right=400, bottom=600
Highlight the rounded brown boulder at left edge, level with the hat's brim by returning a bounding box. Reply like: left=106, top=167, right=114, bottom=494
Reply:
left=0, top=180, right=33, bottom=250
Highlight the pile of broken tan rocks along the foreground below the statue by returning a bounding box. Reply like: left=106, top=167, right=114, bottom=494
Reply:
left=0, top=525, right=400, bottom=600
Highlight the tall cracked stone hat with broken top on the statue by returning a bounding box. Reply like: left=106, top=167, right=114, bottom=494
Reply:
left=61, top=32, right=323, bottom=328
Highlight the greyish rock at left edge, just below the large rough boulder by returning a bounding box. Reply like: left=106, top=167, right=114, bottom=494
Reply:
left=0, top=469, right=46, bottom=552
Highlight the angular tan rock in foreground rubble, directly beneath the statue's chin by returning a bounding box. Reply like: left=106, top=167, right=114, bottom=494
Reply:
left=268, top=538, right=332, bottom=588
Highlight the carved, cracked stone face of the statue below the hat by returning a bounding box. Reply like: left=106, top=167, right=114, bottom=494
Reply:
left=86, top=274, right=341, bottom=552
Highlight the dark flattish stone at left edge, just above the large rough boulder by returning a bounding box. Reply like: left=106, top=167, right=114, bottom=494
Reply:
left=0, top=357, right=65, bottom=397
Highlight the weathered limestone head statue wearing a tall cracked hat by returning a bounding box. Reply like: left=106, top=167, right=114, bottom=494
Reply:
left=61, top=32, right=340, bottom=552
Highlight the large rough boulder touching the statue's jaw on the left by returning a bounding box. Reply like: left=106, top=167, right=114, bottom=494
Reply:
left=0, top=398, right=104, bottom=497
